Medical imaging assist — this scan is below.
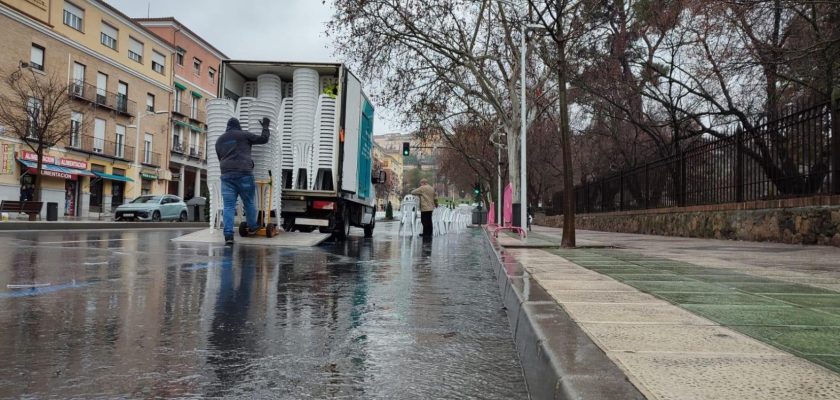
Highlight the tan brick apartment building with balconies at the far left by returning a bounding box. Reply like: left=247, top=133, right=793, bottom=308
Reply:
left=0, top=0, right=175, bottom=218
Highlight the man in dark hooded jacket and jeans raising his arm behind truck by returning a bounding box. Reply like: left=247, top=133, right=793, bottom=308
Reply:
left=216, top=118, right=271, bottom=245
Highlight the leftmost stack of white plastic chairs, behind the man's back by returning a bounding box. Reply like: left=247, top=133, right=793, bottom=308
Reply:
left=207, top=99, right=235, bottom=229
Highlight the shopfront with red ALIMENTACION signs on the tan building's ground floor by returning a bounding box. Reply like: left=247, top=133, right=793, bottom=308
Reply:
left=17, top=150, right=95, bottom=217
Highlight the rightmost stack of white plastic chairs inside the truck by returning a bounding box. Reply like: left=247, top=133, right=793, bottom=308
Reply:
left=308, top=94, right=338, bottom=190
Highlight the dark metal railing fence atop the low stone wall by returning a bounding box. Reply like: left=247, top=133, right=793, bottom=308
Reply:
left=553, top=103, right=840, bottom=213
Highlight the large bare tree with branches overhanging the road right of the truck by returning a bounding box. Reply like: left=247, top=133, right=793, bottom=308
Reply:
left=328, top=0, right=551, bottom=203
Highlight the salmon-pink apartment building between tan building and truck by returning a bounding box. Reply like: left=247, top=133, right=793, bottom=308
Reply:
left=135, top=17, right=227, bottom=199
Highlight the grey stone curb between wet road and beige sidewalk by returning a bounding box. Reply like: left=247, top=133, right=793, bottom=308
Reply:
left=483, top=230, right=645, bottom=399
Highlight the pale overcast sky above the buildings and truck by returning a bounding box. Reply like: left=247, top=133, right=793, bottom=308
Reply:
left=106, top=0, right=399, bottom=134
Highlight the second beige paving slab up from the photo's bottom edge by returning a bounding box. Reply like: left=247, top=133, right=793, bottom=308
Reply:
left=580, top=323, right=782, bottom=354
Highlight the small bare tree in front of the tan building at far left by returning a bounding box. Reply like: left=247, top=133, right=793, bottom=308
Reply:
left=0, top=68, right=81, bottom=200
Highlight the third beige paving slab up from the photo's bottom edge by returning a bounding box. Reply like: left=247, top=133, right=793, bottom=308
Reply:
left=563, top=303, right=715, bottom=325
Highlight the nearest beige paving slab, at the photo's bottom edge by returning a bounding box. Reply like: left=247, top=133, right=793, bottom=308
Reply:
left=611, top=353, right=840, bottom=400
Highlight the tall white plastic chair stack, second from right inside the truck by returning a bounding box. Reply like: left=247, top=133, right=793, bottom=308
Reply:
left=292, top=68, right=320, bottom=188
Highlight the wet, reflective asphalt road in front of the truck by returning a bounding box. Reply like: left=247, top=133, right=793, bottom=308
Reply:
left=0, top=223, right=527, bottom=399
